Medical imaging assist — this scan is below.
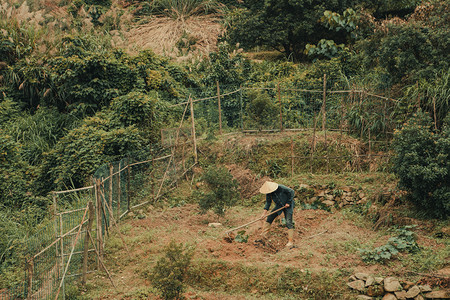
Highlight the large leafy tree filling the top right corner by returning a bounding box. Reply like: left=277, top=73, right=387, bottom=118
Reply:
left=353, top=1, right=450, bottom=84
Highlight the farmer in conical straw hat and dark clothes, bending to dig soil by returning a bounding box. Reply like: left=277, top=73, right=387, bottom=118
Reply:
left=259, top=181, right=295, bottom=247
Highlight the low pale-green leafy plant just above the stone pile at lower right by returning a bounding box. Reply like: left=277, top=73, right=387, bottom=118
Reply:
left=359, top=226, right=420, bottom=262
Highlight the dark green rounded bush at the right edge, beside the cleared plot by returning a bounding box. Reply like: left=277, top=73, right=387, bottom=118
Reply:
left=393, top=111, right=450, bottom=218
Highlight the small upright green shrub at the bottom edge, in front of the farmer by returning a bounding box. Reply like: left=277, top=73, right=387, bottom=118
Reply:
left=150, top=241, right=194, bottom=300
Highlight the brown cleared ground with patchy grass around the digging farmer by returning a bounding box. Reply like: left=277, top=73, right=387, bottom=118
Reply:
left=77, top=174, right=450, bottom=299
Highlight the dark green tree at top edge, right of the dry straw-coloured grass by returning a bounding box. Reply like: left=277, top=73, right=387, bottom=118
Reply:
left=227, top=0, right=357, bottom=60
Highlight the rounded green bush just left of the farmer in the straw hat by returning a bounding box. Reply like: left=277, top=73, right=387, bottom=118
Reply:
left=196, top=166, right=239, bottom=216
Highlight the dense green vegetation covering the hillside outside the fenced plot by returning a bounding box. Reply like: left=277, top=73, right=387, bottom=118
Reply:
left=0, top=0, right=450, bottom=290
